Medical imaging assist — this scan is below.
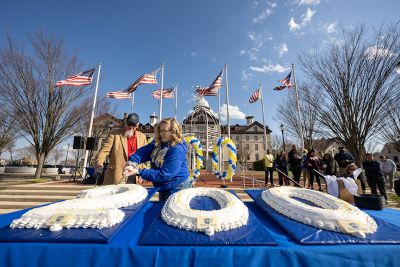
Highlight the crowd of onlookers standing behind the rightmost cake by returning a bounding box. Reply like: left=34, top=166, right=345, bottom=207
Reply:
left=264, top=145, right=397, bottom=203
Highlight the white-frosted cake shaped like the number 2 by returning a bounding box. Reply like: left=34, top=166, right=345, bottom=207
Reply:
left=10, top=184, right=147, bottom=231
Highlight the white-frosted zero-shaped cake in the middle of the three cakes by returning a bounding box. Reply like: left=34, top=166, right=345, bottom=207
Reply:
left=161, top=188, right=249, bottom=236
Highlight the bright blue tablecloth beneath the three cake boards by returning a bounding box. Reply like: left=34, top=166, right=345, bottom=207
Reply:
left=0, top=197, right=400, bottom=267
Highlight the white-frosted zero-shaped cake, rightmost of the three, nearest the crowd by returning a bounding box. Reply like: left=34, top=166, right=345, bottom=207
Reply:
left=262, top=186, right=378, bottom=238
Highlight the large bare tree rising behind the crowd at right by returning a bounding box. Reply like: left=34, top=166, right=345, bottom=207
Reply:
left=300, top=23, right=400, bottom=164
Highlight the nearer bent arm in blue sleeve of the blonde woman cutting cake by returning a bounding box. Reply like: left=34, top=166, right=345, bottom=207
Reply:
left=139, top=145, right=186, bottom=182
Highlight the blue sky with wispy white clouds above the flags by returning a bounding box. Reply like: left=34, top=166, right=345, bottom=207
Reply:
left=0, top=0, right=400, bottom=154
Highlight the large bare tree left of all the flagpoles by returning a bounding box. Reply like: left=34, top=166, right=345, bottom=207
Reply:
left=0, top=31, right=90, bottom=178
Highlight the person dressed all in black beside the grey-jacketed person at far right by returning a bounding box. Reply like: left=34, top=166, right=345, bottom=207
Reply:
left=362, top=153, right=387, bottom=204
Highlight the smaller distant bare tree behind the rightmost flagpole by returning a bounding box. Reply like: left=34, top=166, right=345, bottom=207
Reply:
left=275, top=83, right=321, bottom=148
